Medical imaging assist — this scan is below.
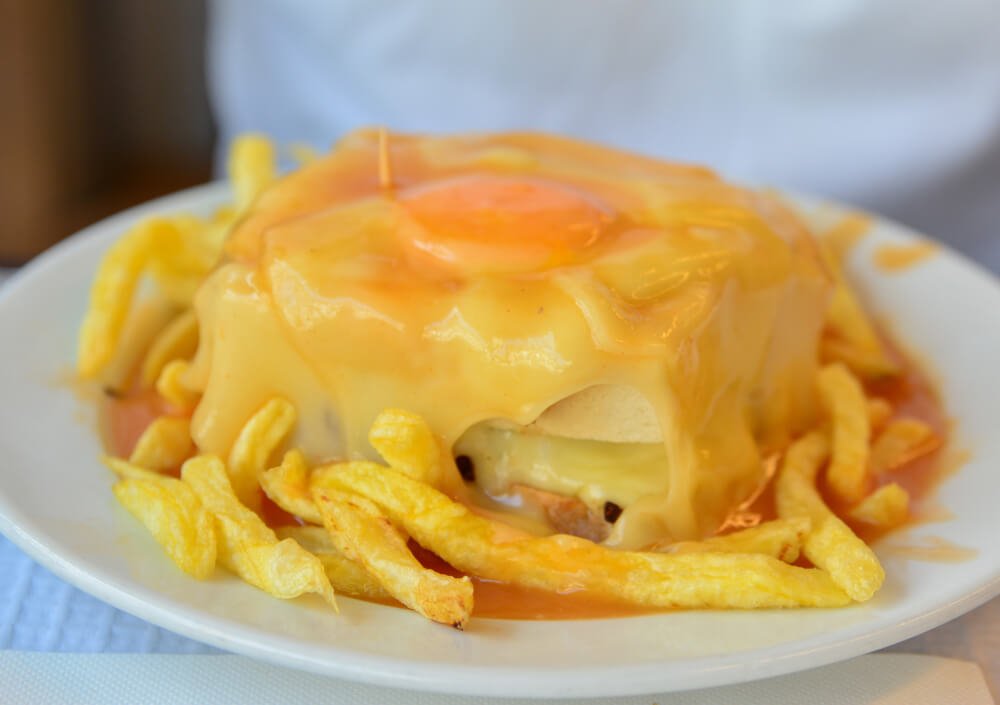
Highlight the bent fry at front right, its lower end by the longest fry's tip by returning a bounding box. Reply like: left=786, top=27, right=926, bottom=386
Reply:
left=774, top=431, right=885, bottom=602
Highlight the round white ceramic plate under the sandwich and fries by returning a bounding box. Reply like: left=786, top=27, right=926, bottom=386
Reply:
left=0, top=185, right=1000, bottom=697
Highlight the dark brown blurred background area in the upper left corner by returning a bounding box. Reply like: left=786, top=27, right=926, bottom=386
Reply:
left=0, top=0, right=214, bottom=266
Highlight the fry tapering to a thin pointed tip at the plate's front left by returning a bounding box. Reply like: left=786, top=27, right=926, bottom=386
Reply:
left=181, top=455, right=337, bottom=609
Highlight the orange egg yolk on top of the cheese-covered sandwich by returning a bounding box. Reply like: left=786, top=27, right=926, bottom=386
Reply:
left=399, top=176, right=612, bottom=271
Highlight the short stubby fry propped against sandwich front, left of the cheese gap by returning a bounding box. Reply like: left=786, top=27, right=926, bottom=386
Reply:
left=368, top=409, right=441, bottom=485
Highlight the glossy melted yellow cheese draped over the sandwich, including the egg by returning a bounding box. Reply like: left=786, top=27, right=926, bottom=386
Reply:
left=184, top=131, right=829, bottom=547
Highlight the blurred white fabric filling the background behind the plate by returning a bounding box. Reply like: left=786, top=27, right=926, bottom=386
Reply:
left=209, top=0, right=1000, bottom=271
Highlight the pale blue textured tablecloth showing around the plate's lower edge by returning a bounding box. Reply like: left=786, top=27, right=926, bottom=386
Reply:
left=0, top=269, right=1000, bottom=693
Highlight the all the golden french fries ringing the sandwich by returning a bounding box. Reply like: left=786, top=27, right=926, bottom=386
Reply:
left=78, top=136, right=941, bottom=629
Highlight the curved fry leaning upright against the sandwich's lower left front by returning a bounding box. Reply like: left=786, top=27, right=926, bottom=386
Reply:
left=228, top=397, right=296, bottom=509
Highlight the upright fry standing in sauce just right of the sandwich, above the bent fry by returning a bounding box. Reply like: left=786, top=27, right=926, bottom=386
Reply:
left=817, top=363, right=871, bottom=502
